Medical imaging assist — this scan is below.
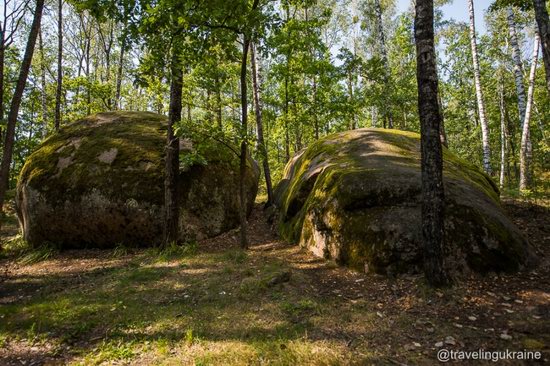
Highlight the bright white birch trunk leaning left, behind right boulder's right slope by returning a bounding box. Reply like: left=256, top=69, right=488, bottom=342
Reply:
left=468, top=0, right=491, bottom=174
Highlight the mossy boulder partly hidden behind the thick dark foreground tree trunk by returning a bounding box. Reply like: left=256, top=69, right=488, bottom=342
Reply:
left=275, top=129, right=534, bottom=275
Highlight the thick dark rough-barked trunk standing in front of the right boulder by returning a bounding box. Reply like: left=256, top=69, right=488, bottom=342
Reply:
left=414, top=0, right=451, bottom=286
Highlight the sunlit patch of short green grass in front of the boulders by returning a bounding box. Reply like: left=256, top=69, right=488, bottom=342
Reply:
left=0, top=246, right=366, bottom=365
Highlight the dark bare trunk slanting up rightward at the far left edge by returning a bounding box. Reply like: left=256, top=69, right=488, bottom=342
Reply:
left=0, top=0, right=44, bottom=212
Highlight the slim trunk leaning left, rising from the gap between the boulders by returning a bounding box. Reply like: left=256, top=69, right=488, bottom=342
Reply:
left=250, top=43, right=273, bottom=207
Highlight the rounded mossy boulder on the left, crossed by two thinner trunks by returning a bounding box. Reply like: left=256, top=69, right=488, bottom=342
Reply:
left=16, top=112, right=259, bottom=248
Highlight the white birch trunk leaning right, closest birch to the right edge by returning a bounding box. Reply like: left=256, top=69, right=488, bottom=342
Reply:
left=519, top=33, right=540, bottom=191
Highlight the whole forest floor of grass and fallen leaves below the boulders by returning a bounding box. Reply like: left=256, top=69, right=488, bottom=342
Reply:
left=0, top=201, right=550, bottom=365
